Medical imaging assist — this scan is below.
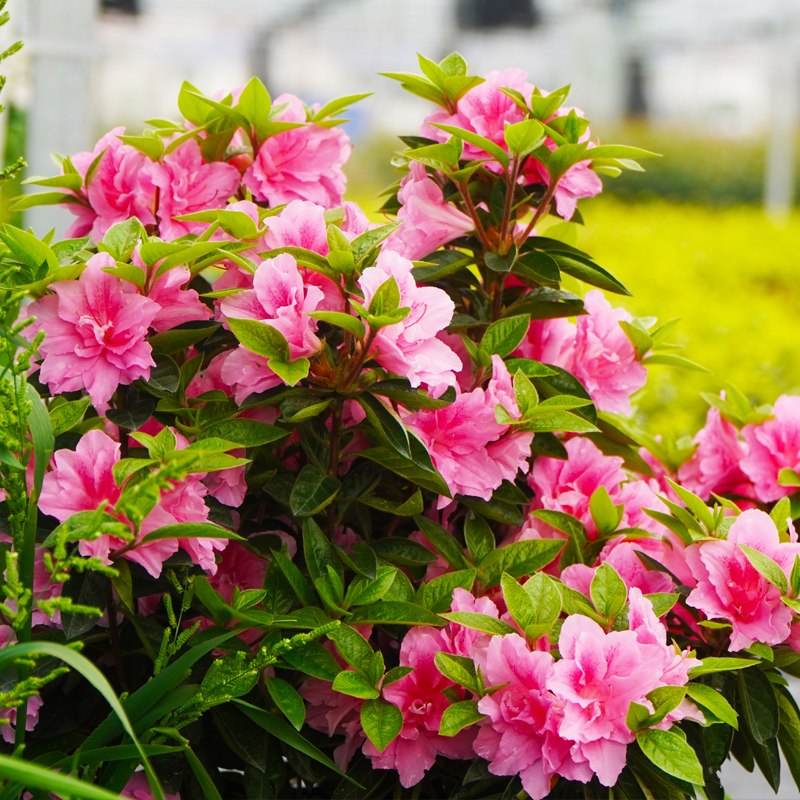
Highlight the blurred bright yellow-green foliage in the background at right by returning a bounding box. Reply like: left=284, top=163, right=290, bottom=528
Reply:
left=579, top=198, right=800, bottom=434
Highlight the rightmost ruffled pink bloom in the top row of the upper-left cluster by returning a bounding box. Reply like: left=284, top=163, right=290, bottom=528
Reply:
left=243, top=94, right=351, bottom=208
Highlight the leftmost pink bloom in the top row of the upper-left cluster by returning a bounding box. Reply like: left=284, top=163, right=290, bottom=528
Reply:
left=66, top=128, right=156, bottom=242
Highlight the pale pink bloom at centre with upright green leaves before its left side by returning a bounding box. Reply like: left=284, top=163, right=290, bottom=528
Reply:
left=358, top=250, right=461, bottom=386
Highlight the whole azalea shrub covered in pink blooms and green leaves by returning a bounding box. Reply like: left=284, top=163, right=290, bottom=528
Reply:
left=0, top=53, right=800, bottom=800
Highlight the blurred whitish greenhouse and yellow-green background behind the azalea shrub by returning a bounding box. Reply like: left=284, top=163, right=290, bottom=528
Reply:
left=0, top=0, right=800, bottom=444
